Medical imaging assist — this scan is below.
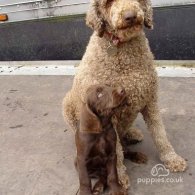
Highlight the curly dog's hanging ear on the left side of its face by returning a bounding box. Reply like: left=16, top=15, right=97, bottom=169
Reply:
left=86, top=0, right=105, bottom=37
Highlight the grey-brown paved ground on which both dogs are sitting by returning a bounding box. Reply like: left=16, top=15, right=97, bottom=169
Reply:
left=0, top=76, right=195, bottom=195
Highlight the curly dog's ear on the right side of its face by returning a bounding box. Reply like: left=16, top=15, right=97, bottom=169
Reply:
left=142, top=0, right=153, bottom=29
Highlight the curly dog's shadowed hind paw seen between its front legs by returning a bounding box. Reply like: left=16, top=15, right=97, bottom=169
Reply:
left=123, top=129, right=144, bottom=145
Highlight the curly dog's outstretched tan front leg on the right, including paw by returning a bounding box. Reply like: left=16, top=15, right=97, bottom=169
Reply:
left=142, top=101, right=187, bottom=172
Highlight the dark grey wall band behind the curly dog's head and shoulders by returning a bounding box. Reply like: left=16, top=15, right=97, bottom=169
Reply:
left=0, top=5, right=195, bottom=61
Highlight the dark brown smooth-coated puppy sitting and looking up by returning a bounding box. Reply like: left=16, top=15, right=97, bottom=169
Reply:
left=75, top=85, right=145, bottom=195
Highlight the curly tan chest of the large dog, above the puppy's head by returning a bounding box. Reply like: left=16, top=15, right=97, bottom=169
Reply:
left=75, top=36, right=157, bottom=111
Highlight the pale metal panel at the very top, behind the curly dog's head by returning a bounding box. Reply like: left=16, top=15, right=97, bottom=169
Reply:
left=0, top=0, right=195, bottom=23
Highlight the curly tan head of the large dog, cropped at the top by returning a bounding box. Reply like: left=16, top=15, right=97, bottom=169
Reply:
left=86, top=0, right=153, bottom=41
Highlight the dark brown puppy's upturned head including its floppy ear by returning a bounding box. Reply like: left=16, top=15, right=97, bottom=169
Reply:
left=80, top=85, right=126, bottom=133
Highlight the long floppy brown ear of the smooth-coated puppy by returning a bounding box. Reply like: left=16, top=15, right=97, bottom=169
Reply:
left=80, top=103, right=102, bottom=133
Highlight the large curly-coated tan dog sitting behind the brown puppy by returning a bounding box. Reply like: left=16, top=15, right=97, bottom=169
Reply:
left=63, top=0, right=187, bottom=190
